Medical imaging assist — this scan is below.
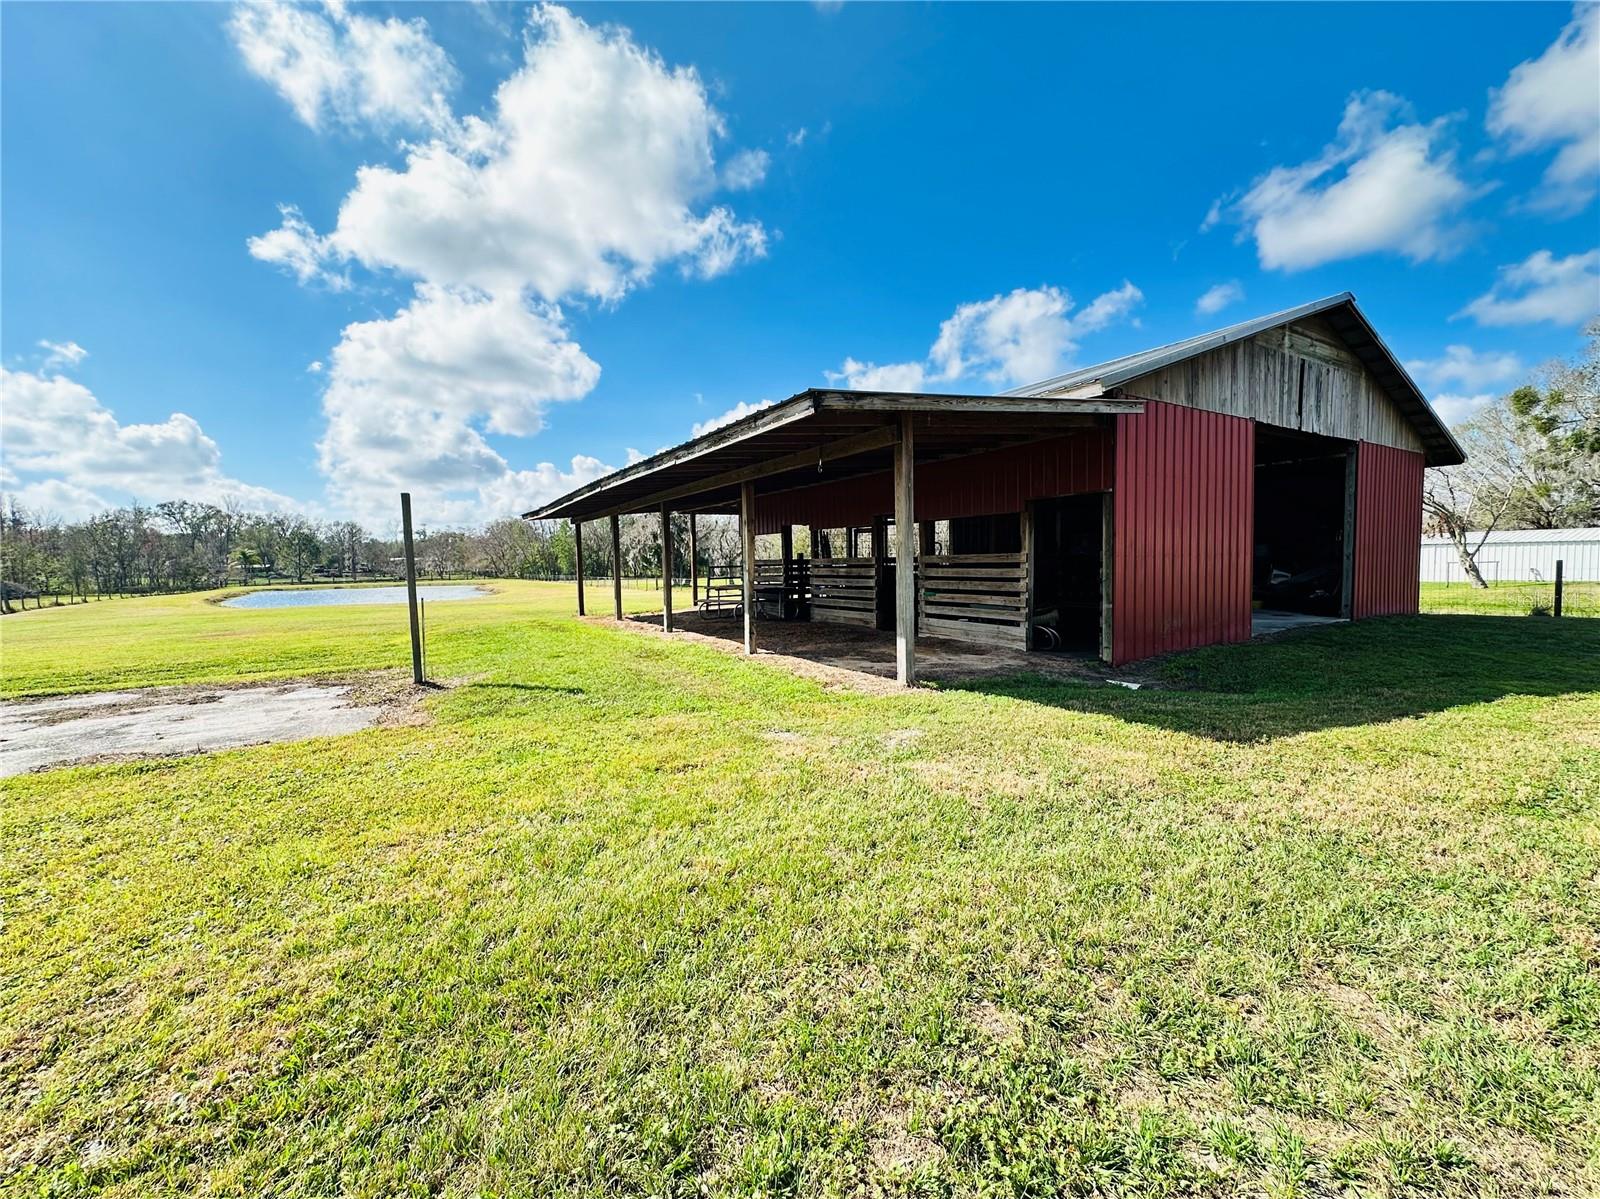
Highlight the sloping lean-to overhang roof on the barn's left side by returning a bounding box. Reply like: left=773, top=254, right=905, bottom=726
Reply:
left=523, top=389, right=1144, bottom=520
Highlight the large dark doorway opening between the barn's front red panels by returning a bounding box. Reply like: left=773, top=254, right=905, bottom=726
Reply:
left=1251, top=424, right=1355, bottom=616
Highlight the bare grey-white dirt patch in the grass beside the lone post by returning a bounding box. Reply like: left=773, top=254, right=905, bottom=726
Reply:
left=0, top=676, right=419, bottom=776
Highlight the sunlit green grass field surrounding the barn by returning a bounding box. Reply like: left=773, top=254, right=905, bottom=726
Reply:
left=0, top=583, right=1600, bottom=1196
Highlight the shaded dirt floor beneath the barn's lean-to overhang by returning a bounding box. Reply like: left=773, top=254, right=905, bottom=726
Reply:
left=606, top=612, right=1131, bottom=692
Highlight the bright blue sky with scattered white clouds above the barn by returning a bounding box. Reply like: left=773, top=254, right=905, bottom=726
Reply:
left=0, top=3, right=1600, bottom=525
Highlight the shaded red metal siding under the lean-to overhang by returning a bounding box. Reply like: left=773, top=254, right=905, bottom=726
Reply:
left=755, top=429, right=1115, bottom=533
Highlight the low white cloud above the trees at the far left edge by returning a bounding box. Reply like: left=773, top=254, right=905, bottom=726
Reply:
left=0, top=361, right=291, bottom=517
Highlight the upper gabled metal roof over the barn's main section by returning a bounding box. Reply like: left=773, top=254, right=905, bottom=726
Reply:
left=1006, top=291, right=1467, bottom=466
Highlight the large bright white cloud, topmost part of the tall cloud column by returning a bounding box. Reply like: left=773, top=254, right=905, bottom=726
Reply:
left=307, top=6, right=766, bottom=299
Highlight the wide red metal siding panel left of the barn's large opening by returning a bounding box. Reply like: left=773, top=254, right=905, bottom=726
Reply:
left=1112, top=402, right=1254, bottom=663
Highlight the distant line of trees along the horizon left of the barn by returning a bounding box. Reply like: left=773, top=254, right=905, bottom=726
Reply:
left=0, top=499, right=755, bottom=612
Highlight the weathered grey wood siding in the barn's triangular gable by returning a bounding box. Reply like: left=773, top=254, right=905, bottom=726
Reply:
left=1120, top=320, right=1422, bottom=451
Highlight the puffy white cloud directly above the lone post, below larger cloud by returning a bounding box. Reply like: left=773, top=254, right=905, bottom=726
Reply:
left=318, top=283, right=600, bottom=520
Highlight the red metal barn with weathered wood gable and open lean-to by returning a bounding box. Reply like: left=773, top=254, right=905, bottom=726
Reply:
left=525, top=293, right=1462, bottom=684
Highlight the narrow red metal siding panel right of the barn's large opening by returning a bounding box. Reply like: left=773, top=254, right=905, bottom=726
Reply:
left=1350, top=442, right=1424, bottom=620
